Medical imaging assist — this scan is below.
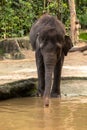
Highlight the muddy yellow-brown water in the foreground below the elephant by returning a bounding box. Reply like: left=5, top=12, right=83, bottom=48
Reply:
left=0, top=97, right=87, bottom=130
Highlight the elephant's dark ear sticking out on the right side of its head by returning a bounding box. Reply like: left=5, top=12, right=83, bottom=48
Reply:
left=63, top=35, right=73, bottom=56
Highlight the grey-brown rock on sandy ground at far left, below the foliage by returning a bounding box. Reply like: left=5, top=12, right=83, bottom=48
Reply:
left=0, top=39, right=25, bottom=59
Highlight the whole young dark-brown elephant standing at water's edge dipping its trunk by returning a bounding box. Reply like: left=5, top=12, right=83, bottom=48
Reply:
left=30, top=15, right=73, bottom=106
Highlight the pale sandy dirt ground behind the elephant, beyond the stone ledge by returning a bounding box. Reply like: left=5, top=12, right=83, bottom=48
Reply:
left=0, top=44, right=87, bottom=84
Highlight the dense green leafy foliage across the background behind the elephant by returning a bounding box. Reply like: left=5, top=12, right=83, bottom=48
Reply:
left=0, top=0, right=87, bottom=38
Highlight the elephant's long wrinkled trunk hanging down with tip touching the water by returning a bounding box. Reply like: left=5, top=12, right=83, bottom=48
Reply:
left=44, top=56, right=57, bottom=106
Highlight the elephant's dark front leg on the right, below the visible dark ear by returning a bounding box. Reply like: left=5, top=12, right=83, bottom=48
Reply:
left=51, top=57, right=64, bottom=97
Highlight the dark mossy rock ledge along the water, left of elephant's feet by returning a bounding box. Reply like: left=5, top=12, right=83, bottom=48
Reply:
left=0, top=79, right=37, bottom=100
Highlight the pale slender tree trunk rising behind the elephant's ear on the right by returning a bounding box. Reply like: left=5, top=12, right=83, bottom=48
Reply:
left=68, top=0, right=76, bottom=44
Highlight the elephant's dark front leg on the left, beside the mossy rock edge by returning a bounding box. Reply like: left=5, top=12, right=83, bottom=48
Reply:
left=36, top=51, right=45, bottom=96
